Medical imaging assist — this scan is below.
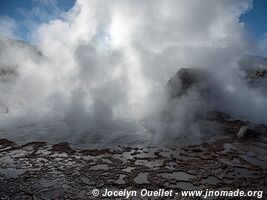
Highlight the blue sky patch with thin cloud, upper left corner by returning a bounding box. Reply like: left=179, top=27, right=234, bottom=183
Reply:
left=0, top=0, right=75, bottom=42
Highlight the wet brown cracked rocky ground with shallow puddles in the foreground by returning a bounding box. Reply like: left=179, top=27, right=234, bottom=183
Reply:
left=0, top=114, right=267, bottom=200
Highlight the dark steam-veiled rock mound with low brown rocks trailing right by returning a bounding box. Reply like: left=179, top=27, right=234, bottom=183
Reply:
left=164, top=68, right=267, bottom=139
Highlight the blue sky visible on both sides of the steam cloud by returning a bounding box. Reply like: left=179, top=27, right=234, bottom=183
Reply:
left=0, top=0, right=267, bottom=52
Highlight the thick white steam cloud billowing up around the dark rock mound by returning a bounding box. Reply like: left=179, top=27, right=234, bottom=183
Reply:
left=0, top=0, right=267, bottom=145
